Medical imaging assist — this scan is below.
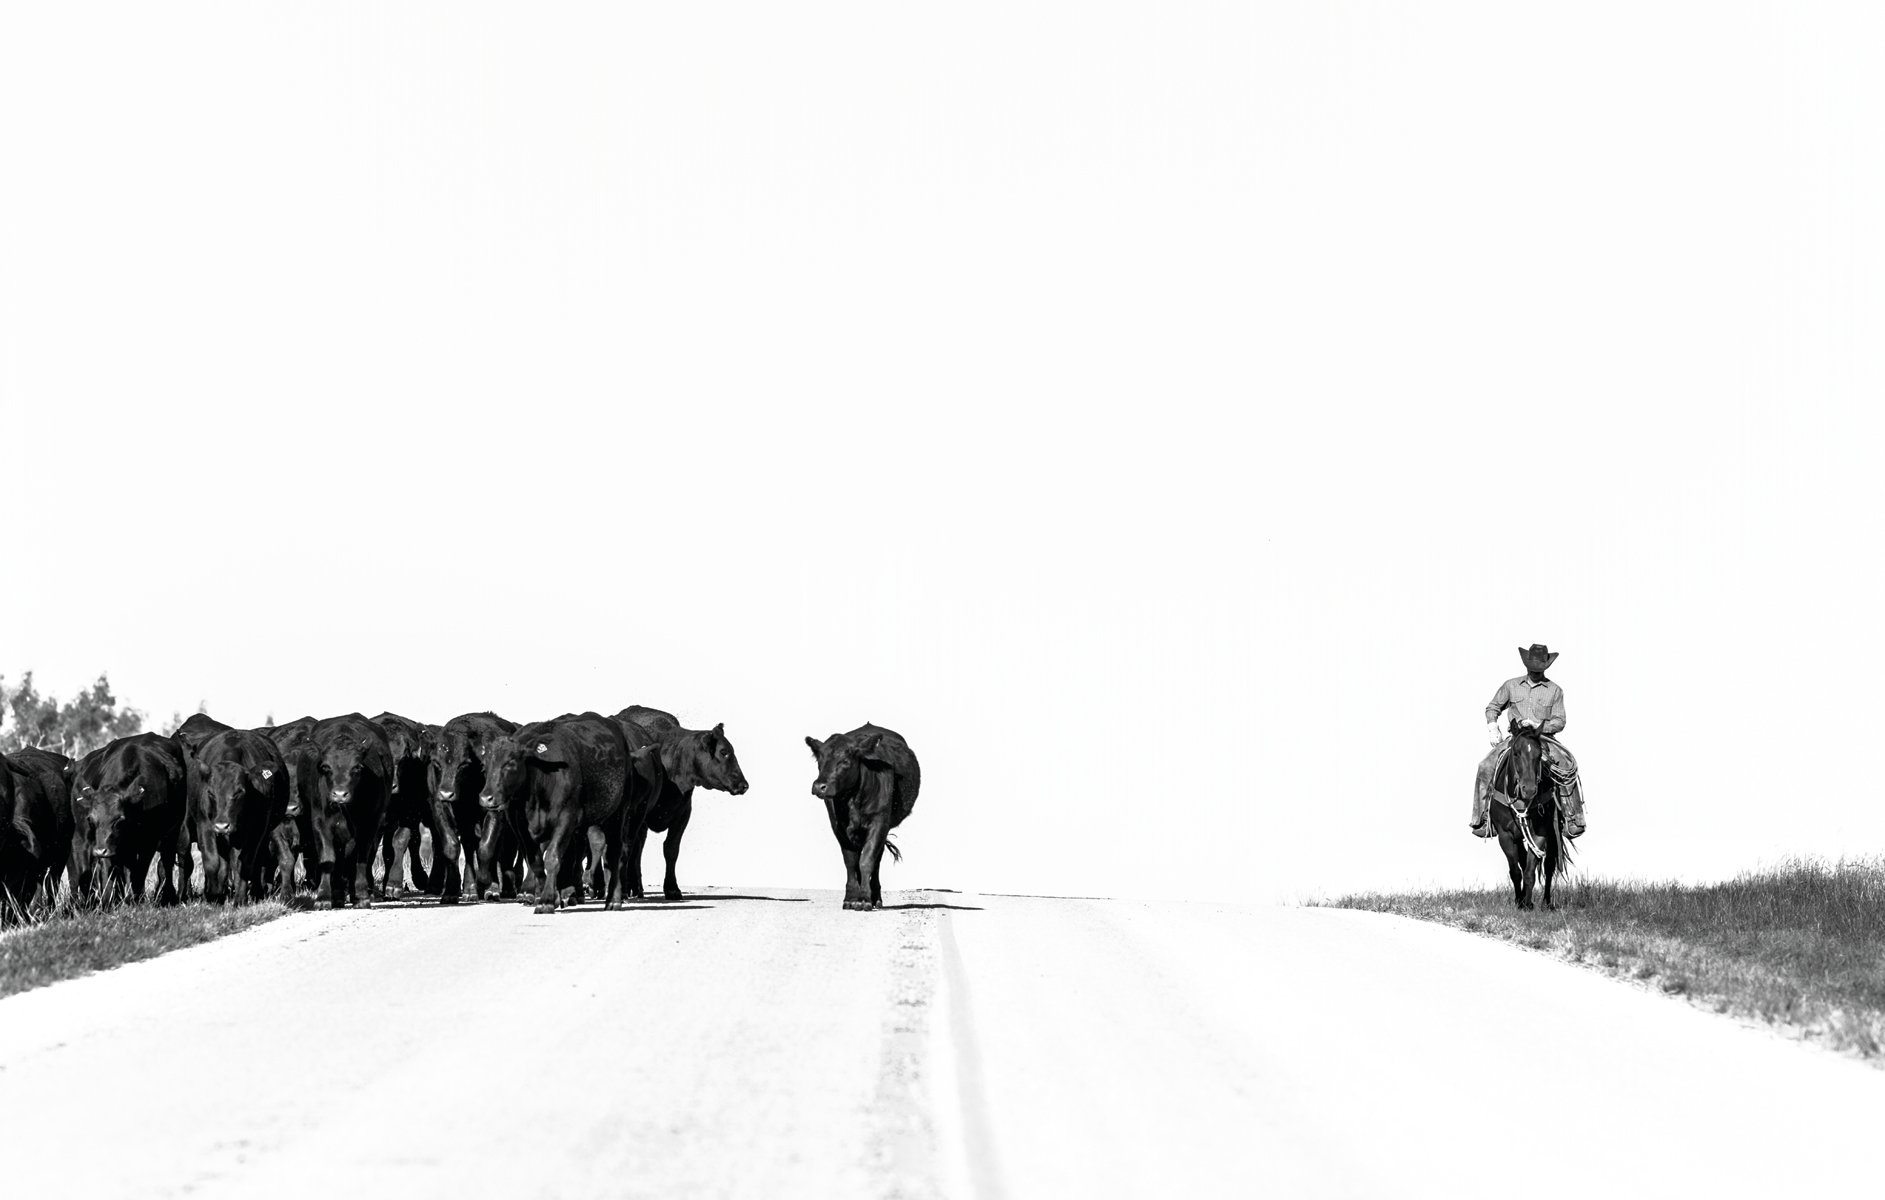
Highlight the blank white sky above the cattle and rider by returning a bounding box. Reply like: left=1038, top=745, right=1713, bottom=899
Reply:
left=0, top=0, right=1885, bottom=897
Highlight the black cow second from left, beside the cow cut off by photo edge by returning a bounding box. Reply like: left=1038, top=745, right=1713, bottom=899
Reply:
left=72, top=733, right=189, bottom=904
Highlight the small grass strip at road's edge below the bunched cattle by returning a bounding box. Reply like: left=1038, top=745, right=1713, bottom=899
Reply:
left=0, top=900, right=288, bottom=997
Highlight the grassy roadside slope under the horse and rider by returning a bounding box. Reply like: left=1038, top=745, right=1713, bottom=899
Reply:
left=1327, top=859, right=1885, bottom=1066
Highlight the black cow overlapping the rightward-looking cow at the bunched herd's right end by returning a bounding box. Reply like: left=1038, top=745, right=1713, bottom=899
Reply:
left=479, top=712, right=628, bottom=912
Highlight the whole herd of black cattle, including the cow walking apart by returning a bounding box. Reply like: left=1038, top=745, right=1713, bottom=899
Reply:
left=0, top=705, right=920, bottom=919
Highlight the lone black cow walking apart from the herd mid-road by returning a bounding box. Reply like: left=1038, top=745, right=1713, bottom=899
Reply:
left=805, top=722, right=922, bottom=908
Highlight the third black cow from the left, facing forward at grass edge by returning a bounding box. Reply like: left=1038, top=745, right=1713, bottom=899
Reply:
left=190, top=729, right=294, bottom=904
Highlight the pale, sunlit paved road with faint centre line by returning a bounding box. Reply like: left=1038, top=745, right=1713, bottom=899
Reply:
left=0, top=889, right=1885, bottom=1200
